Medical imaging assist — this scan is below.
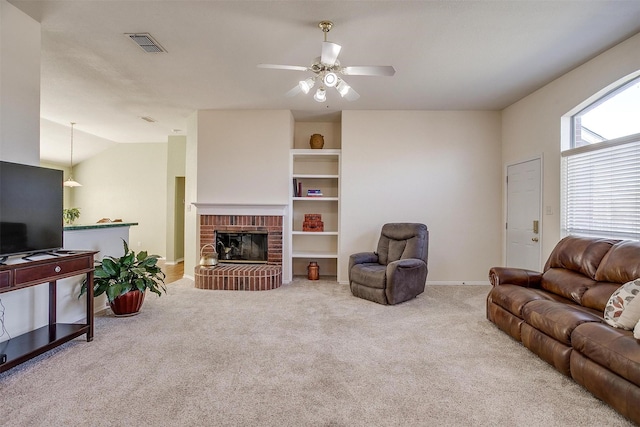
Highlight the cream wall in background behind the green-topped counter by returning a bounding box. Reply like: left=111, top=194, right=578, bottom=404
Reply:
left=72, top=143, right=167, bottom=257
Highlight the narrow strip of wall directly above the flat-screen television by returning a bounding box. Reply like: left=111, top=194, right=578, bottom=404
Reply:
left=0, top=0, right=40, bottom=166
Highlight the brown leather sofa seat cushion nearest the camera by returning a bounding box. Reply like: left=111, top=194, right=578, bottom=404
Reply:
left=571, top=322, right=640, bottom=386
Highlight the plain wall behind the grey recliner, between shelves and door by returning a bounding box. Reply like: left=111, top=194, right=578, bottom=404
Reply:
left=338, top=111, right=501, bottom=283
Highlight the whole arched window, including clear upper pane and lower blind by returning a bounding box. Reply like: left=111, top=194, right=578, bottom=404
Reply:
left=561, top=73, right=640, bottom=240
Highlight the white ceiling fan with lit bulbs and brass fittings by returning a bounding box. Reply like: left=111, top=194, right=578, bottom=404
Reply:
left=258, top=21, right=396, bottom=102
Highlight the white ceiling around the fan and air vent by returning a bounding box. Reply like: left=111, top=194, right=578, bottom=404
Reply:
left=9, top=0, right=640, bottom=164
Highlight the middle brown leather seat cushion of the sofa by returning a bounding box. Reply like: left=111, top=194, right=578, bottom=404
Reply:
left=522, top=300, right=602, bottom=345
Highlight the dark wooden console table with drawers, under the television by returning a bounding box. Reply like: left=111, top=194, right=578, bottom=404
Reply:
left=0, top=251, right=97, bottom=372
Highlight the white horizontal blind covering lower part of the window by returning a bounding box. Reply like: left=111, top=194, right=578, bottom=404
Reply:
left=562, top=140, right=640, bottom=240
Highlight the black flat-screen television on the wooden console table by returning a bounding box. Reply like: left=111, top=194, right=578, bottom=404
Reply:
left=0, top=161, right=63, bottom=258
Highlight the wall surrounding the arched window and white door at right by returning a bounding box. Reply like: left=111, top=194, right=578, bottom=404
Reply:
left=501, top=30, right=640, bottom=263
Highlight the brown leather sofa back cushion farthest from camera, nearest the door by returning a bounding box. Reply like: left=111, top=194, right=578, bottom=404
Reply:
left=544, top=236, right=622, bottom=283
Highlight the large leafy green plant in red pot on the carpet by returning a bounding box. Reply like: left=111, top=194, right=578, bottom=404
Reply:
left=80, top=239, right=167, bottom=316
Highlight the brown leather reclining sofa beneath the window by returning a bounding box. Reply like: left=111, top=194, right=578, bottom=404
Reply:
left=487, top=237, right=640, bottom=424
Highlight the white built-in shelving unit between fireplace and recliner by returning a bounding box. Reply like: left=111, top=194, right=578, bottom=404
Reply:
left=289, top=149, right=340, bottom=275
